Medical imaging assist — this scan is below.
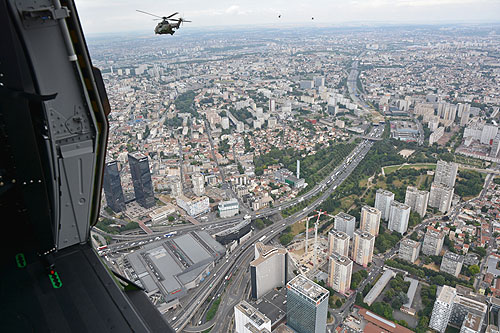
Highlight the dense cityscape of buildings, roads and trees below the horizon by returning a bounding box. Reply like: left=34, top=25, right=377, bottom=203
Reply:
left=87, top=25, right=500, bottom=333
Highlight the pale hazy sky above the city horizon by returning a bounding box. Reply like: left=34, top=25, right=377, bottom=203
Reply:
left=76, top=0, right=500, bottom=33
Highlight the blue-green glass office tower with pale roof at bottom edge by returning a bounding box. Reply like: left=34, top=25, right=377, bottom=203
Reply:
left=286, top=275, right=330, bottom=333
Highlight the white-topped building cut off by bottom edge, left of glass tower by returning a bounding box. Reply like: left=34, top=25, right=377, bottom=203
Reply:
left=234, top=301, right=271, bottom=333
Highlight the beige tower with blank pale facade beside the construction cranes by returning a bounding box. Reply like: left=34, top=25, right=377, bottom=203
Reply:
left=250, top=242, right=288, bottom=299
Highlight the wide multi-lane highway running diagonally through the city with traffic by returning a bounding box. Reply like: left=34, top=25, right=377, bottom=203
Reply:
left=172, top=127, right=383, bottom=330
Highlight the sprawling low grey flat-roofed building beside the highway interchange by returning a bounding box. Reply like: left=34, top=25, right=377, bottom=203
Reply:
left=124, top=231, right=226, bottom=303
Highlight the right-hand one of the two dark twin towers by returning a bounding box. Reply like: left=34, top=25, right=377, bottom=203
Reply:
left=128, top=153, right=155, bottom=208
